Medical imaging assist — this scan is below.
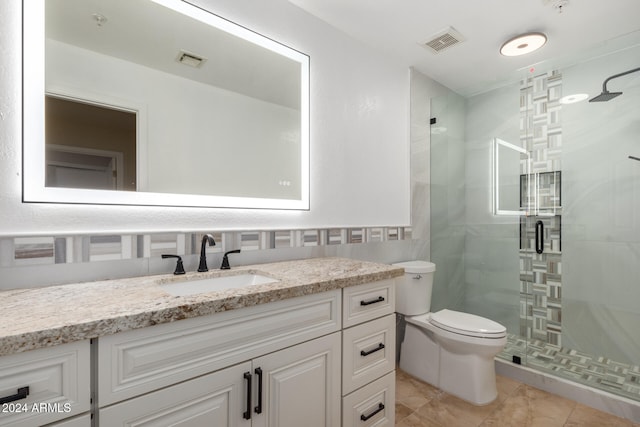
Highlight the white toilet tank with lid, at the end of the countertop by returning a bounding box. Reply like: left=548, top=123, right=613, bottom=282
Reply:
left=393, top=261, right=436, bottom=316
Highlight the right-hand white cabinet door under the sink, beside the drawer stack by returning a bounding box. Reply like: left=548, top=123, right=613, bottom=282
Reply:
left=252, top=333, right=341, bottom=427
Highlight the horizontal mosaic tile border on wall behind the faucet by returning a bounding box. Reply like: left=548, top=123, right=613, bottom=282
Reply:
left=0, top=227, right=411, bottom=267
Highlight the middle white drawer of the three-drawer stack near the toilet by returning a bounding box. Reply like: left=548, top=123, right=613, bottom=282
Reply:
left=342, top=314, right=396, bottom=394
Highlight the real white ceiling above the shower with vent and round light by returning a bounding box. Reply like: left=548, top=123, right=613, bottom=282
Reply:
left=289, top=0, right=640, bottom=96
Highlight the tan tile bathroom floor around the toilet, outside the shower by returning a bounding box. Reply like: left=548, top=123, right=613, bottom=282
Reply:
left=396, top=370, right=640, bottom=427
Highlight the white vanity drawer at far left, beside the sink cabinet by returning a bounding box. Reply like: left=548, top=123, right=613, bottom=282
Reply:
left=0, top=341, right=90, bottom=426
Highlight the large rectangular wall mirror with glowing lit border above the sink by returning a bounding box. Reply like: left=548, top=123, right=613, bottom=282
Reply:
left=23, top=0, right=309, bottom=210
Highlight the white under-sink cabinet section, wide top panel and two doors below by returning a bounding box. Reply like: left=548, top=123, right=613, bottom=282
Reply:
left=97, top=290, right=342, bottom=427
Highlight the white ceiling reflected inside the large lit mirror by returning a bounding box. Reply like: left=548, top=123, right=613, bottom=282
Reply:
left=45, top=0, right=301, bottom=109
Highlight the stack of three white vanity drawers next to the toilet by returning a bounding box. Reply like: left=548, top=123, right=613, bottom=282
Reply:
left=342, top=279, right=396, bottom=427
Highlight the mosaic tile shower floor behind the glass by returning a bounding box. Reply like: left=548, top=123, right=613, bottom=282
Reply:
left=498, top=334, right=640, bottom=401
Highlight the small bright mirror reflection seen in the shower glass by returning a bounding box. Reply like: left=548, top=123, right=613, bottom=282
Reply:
left=492, top=138, right=529, bottom=215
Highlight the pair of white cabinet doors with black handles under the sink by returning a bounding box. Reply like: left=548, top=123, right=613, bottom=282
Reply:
left=100, top=332, right=340, bottom=427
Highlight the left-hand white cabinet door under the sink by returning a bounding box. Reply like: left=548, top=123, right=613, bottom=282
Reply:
left=99, top=362, right=251, bottom=427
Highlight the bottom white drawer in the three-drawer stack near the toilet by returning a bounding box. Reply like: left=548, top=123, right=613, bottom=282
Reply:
left=342, top=371, right=396, bottom=427
